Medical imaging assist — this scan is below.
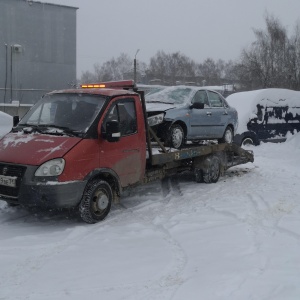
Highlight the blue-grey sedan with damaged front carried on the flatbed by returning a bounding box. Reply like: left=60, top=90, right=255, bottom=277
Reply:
left=145, top=86, right=238, bottom=149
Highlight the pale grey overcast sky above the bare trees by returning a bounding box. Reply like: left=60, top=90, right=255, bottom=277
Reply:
left=47, top=0, right=300, bottom=77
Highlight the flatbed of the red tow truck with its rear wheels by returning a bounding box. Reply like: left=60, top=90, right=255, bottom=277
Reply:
left=144, top=143, right=254, bottom=183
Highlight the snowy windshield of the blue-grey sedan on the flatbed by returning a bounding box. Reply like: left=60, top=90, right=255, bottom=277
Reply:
left=145, top=87, right=195, bottom=104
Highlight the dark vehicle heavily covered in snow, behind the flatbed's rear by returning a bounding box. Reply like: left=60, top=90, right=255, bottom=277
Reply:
left=226, top=88, right=300, bottom=146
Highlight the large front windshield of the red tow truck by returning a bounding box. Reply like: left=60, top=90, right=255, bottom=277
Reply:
left=19, top=93, right=106, bottom=133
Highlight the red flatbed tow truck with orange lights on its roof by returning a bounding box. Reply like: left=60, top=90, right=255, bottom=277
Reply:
left=0, top=80, right=254, bottom=223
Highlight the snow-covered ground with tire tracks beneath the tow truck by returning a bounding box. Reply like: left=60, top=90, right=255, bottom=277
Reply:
left=0, top=134, right=300, bottom=300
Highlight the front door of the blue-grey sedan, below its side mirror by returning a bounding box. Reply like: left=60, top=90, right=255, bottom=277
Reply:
left=188, top=90, right=214, bottom=139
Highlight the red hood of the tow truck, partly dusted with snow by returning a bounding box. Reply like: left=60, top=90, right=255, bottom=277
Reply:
left=0, top=132, right=81, bottom=165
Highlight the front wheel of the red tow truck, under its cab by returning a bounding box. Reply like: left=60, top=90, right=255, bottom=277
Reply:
left=79, top=180, right=113, bottom=224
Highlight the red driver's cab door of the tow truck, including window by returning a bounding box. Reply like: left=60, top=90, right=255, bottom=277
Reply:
left=100, top=98, right=146, bottom=187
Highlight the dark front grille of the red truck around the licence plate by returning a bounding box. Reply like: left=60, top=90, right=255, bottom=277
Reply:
left=0, top=163, right=26, bottom=198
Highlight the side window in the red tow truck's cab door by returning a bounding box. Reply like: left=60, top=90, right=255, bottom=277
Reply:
left=103, top=99, right=137, bottom=136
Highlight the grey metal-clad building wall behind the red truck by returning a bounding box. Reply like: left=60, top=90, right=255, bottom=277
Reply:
left=0, top=0, right=77, bottom=104
